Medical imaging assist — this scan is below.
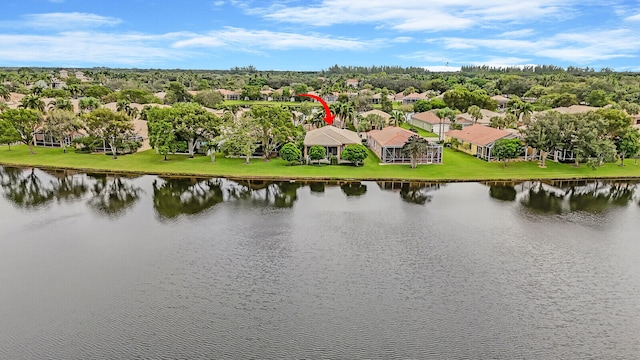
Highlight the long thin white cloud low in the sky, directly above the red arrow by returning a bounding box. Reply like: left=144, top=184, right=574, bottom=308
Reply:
left=173, top=27, right=382, bottom=51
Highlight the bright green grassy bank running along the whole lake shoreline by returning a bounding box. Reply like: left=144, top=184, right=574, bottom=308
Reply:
left=0, top=146, right=640, bottom=181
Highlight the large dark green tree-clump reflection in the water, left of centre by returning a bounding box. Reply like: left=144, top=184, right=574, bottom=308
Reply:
left=153, top=177, right=224, bottom=219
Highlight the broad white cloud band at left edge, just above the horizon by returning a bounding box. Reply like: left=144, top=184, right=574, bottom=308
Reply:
left=0, top=32, right=188, bottom=66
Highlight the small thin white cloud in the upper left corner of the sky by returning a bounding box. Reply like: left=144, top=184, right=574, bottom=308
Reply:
left=14, top=12, right=122, bottom=30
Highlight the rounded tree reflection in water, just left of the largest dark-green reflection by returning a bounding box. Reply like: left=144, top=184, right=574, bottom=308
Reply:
left=87, top=174, right=142, bottom=217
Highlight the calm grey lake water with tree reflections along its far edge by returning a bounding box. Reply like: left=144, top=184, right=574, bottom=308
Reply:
left=0, top=168, right=640, bottom=359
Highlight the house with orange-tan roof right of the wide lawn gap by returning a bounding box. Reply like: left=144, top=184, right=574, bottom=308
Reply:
left=445, top=124, right=517, bottom=161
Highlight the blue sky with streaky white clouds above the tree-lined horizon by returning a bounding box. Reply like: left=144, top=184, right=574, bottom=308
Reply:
left=0, top=0, right=640, bottom=71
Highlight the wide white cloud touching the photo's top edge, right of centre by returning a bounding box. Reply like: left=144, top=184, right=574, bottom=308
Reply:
left=246, top=0, right=579, bottom=31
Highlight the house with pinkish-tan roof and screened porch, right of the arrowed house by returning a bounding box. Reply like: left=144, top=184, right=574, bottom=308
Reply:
left=367, top=126, right=442, bottom=164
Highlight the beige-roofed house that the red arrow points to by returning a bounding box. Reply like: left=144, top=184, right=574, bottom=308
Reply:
left=304, top=125, right=362, bottom=160
